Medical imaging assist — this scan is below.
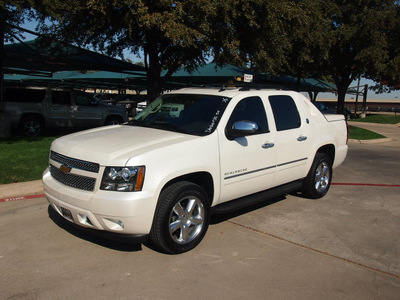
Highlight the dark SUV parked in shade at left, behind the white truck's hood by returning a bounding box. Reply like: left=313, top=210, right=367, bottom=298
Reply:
left=4, top=87, right=128, bottom=136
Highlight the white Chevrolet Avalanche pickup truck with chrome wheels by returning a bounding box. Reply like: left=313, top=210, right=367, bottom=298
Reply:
left=43, top=88, right=348, bottom=253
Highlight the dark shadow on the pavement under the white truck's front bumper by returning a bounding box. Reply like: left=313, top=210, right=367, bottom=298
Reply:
left=47, top=205, right=142, bottom=252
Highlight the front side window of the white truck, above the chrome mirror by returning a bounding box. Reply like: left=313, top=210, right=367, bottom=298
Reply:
left=227, top=97, right=269, bottom=133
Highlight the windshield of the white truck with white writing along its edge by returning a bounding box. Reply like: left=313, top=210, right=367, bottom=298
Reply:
left=129, top=94, right=230, bottom=136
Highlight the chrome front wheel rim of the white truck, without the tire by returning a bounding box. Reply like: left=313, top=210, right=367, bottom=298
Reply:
left=169, top=197, right=205, bottom=244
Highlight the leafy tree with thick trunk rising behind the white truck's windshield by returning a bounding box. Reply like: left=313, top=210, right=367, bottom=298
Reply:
left=36, top=0, right=236, bottom=100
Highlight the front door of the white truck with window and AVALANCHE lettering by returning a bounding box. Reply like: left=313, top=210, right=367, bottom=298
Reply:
left=218, top=96, right=276, bottom=203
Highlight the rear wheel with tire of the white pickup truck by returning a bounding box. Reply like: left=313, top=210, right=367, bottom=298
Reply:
left=303, top=153, right=332, bottom=199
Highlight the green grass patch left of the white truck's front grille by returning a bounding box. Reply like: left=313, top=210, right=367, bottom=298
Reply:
left=0, top=137, right=56, bottom=184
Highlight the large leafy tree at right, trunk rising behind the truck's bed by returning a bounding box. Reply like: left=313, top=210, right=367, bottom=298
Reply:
left=242, top=0, right=400, bottom=113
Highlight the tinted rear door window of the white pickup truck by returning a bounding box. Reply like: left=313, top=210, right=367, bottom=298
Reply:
left=269, top=95, right=301, bottom=131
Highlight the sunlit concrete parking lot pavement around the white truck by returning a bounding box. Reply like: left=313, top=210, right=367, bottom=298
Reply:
left=0, top=125, right=400, bottom=299
